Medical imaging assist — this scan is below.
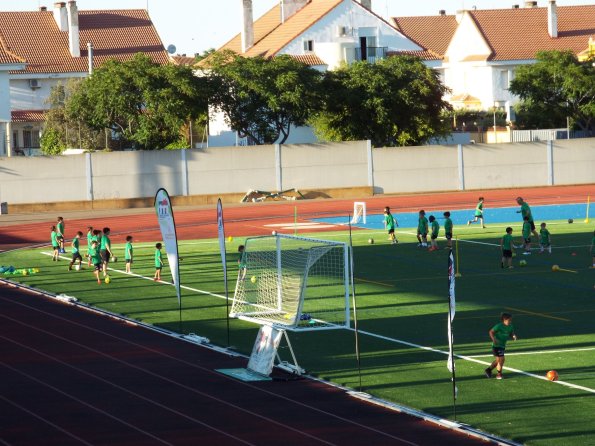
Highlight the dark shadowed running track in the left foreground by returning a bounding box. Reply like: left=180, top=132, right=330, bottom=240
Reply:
left=0, top=285, right=485, bottom=446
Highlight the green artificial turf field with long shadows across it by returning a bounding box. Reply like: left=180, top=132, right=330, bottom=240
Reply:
left=0, top=221, right=595, bottom=445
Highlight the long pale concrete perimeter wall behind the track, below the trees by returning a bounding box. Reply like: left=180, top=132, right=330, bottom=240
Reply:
left=0, top=138, right=595, bottom=212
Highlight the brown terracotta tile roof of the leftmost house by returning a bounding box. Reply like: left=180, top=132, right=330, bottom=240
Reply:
left=0, top=9, right=169, bottom=73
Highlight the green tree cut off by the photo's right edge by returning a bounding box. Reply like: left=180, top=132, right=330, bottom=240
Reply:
left=510, top=51, right=595, bottom=131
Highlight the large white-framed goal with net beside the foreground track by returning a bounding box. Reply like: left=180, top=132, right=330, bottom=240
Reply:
left=230, top=234, right=350, bottom=330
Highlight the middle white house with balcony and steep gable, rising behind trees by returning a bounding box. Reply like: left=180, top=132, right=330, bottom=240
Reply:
left=209, top=0, right=422, bottom=146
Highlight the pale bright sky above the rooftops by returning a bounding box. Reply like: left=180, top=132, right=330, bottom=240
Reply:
left=0, top=0, right=595, bottom=56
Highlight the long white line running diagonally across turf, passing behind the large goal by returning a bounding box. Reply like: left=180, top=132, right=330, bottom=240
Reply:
left=42, top=252, right=595, bottom=394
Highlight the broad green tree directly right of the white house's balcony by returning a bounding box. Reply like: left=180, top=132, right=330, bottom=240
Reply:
left=311, top=56, right=451, bottom=147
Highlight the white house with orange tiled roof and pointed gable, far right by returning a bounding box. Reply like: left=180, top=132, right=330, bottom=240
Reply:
left=393, top=0, right=595, bottom=120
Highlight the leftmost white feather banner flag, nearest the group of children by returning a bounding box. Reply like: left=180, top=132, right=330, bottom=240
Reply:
left=153, top=188, right=182, bottom=333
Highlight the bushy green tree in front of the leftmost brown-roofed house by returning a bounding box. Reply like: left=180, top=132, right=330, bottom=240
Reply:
left=67, top=53, right=207, bottom=149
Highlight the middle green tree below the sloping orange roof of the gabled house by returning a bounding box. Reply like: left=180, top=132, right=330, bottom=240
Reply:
left=205, top=51, right=321, bottom=144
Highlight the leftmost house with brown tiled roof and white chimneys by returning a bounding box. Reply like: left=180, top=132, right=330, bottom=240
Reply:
left=0, top=1, right=169, bottom=156
